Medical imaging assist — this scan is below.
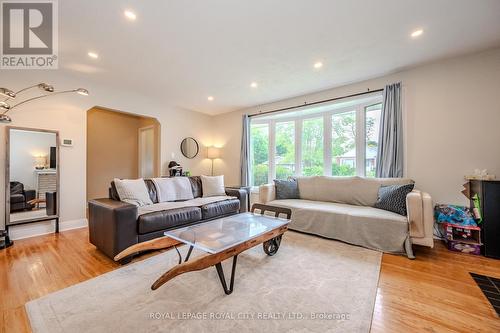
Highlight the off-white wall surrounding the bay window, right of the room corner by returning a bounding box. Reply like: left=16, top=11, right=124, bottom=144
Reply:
left=214, top=48, right=500, bottom=204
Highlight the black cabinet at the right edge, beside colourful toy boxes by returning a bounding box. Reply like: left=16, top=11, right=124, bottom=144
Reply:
left=470, top=180, right=500, bottom=259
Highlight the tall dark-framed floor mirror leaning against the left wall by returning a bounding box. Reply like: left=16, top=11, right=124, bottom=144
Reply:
left=5, top=126, right=59, bottom=232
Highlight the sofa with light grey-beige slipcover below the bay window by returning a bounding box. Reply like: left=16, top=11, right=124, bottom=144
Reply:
left=259, top=176, right=434, bottom=258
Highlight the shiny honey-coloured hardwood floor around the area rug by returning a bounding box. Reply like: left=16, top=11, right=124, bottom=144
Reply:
left=0, top=229, right=500, bottom=333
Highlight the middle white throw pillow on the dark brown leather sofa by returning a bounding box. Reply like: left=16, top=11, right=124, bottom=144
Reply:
left=151, top=177, right=194, bottom=202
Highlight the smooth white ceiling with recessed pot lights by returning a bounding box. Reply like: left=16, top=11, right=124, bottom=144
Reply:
left=59, top=0, right=500, bottom=114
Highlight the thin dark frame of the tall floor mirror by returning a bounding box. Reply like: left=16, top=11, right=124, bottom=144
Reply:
left=4, top=126, right=61, bottom=228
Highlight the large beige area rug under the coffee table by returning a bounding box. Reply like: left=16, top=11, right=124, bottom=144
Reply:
left=26, top=232, right=381, bottom=333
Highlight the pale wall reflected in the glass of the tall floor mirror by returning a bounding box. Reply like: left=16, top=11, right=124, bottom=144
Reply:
left=10, top=130, right=56, bottom=190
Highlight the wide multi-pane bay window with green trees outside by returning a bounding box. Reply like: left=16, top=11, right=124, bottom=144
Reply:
left=249, top=93, right=382, bottom=186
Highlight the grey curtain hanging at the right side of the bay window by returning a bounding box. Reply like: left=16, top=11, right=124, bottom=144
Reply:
left=376, top=82, right=403, bottom=178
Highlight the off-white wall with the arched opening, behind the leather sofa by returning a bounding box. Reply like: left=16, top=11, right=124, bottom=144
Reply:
left=0, top=70, right=212, bottom=236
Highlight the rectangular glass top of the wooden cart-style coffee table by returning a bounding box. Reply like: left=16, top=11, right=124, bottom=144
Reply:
left=164, top=213, right=289, bottom=253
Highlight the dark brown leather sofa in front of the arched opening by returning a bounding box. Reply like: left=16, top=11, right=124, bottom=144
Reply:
left=89, top=176, right=248, bottom=263
